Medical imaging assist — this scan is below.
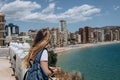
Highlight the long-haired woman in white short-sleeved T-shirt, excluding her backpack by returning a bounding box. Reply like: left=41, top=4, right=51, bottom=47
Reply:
left=24, top=29, right=59, bottom=76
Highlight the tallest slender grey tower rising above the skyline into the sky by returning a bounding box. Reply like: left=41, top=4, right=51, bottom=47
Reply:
left=60, top=20, right=68, bottom=46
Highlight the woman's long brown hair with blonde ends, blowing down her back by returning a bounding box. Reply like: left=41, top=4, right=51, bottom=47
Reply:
left=24, top=29, right=51, bottom=67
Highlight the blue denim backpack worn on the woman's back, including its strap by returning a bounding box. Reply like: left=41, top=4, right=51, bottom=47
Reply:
left=23, top=48, right=49, bottom=80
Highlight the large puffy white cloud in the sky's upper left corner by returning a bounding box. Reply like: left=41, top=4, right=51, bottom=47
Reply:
left=0, top=0, right=41, bottom=20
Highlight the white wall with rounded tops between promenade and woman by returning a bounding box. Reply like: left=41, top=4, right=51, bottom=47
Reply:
left=9, top=42, right=30, bottom=80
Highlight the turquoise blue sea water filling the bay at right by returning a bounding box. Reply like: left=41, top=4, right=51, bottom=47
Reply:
left=57, top=43, right=120, bottom=80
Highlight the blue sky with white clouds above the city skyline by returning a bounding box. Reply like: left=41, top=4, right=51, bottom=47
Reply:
left=0, top=0, right=120, bottom=32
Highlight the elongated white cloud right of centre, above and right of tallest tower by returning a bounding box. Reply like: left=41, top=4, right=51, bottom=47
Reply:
left=55, top=4, right=100, bottom=22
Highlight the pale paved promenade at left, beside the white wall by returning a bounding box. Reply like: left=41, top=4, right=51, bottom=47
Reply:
left=0, top=48, right=16, bottom=80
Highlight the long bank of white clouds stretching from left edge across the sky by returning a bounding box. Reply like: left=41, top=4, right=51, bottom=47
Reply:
left=0, top=0, right=101, bottom=23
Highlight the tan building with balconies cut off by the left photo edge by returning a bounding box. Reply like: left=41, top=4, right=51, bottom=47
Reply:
left=0, top=13, right=6, bottom=46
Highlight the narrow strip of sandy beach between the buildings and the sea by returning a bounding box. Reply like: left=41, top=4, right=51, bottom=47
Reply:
left=54, top=41, right=120, bottom=55
